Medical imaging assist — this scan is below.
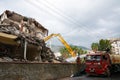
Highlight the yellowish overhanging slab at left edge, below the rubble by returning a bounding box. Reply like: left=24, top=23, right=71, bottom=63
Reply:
left=0, top=32, right=18, bottom=45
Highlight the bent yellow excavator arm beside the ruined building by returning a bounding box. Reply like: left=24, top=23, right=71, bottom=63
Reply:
left=44, top=34, right=76, bottom=57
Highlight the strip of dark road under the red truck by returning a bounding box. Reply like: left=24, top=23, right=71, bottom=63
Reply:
left=59, top=72, right=120, bottom=80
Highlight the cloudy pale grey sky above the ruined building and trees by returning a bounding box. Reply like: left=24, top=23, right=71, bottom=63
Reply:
left=0, top=0, right=120, bottom=48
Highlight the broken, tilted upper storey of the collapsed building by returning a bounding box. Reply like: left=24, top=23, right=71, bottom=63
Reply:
left=0, top=10, right=48, bottom=38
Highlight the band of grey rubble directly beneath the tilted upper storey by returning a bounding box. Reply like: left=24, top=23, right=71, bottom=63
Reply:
left=0, top=25, right=44, bottom=46
